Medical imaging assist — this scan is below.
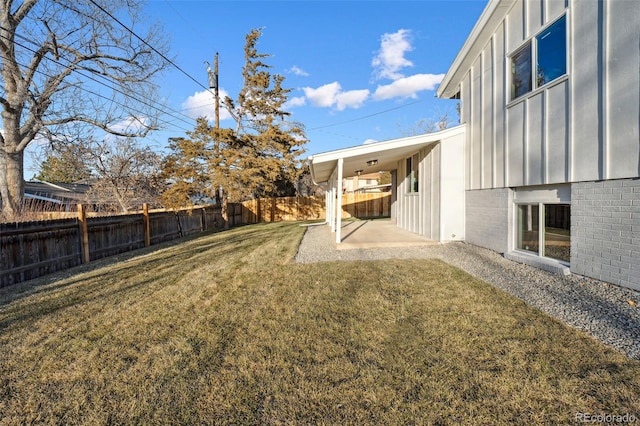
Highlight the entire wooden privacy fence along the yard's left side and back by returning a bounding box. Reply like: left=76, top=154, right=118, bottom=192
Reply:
left=0, top=193, right=391, bottom=288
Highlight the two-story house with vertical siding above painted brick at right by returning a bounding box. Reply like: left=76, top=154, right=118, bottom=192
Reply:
left=437, top=0, right=640, bottom=290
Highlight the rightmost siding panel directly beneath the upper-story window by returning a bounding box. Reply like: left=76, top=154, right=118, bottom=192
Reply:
left=545, top=80, right=569, bottom=183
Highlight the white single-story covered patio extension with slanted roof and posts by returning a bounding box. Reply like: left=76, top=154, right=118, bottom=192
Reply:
left=310, top=126, right=465, bottom=243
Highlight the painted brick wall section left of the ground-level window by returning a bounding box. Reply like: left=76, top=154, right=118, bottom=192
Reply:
left=465, top=188, right=511, bottom=253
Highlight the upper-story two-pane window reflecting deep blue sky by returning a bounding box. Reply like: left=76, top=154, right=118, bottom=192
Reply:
left=510, top=16, right=567, bottom=99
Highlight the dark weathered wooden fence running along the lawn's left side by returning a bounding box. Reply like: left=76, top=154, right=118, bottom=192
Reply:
left=0, top=204, right=243, bottom=288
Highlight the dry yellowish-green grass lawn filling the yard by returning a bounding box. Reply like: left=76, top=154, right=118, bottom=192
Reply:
left=0, top=224, right=640, bottom=425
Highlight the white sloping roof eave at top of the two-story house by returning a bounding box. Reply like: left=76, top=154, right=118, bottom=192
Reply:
left=436, top=0, right=516, bottom=98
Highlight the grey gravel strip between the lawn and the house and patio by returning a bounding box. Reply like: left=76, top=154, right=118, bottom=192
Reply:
left=296, top=225, right=640, bottom=360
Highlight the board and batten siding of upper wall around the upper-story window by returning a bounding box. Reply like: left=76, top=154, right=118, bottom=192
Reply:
left=460, top=0, right=640, bottom=190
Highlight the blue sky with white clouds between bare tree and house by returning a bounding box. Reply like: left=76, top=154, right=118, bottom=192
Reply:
left=27, top=0, right=486, bottom=177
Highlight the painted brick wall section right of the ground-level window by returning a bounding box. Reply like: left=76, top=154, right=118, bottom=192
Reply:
left=572, top=179, right=640, bottom=290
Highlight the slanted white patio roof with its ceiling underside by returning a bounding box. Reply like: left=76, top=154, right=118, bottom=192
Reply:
left=309, top=126, right=464, bottom=183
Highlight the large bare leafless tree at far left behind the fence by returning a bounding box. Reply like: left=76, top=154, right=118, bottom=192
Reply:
left=0, top=0, right=166, bottom=214
